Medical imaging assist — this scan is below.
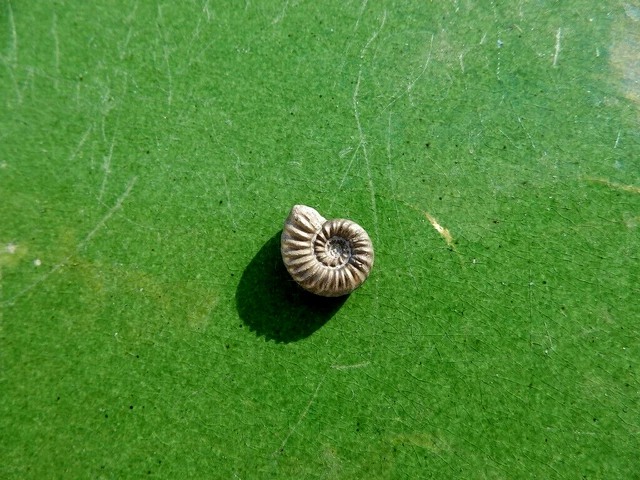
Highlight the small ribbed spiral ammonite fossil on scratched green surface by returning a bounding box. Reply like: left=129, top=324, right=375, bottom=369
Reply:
left=280, top=205, right=373, bottom=297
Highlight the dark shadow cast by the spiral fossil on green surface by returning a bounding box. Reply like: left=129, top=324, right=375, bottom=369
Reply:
left=236, top=232, right=348, bottom=343
